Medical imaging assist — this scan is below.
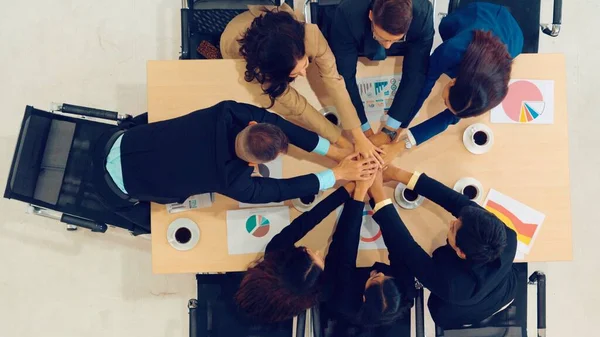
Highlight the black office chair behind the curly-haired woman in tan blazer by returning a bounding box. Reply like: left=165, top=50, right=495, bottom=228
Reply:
left=179, top=0, right=294, bottom=60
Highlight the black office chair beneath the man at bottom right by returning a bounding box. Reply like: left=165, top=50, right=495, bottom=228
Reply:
left=435, top=263, right=546, bottom=337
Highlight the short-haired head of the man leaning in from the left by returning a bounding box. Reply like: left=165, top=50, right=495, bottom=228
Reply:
left=235, top=122, right=289, bottom=164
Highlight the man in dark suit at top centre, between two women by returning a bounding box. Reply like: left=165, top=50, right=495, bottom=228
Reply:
left=329, top=0, right=435, bottom=141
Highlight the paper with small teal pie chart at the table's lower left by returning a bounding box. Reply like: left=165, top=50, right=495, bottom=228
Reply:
left=227, top=206, right=290, bottom=255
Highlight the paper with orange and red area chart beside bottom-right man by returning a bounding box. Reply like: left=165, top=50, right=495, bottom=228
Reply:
left=484, top=189, right=546, bottom=259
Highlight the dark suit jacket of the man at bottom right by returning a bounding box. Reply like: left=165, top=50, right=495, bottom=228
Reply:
left=373, top=174, right=517, bottom=327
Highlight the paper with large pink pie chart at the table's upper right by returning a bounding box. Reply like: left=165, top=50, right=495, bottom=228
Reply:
left=491, top=80, right=554, bottom=124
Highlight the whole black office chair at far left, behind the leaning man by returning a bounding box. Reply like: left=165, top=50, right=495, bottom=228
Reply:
left=4, top=104, right=150, bottom=235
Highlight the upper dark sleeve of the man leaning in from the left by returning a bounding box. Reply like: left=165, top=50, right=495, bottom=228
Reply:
left=224, top=101, right=319, bottom=152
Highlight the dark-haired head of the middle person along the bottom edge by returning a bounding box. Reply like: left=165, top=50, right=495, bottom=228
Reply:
left=357, top=270, right=411, bottom=326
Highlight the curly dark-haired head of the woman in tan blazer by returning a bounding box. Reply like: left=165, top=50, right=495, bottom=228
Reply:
left=239, top=10, right=309, bottom=106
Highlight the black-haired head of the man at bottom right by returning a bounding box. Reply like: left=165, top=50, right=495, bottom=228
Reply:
left=448, top=206, right=506, bottom=264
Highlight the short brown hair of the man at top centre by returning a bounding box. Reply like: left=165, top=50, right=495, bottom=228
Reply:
left=372, top=0, right=412, bottom=35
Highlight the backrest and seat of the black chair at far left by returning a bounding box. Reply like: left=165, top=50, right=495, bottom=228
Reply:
left=4, top=106, right=148, bottom=232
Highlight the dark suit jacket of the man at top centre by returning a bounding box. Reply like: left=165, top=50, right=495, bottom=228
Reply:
left=329, top=0, right=435, bottom=124
